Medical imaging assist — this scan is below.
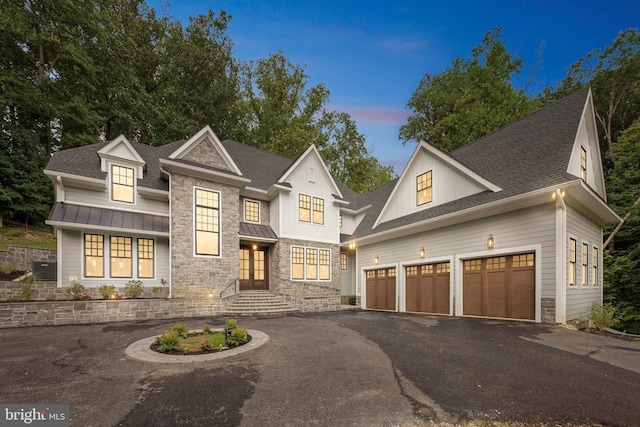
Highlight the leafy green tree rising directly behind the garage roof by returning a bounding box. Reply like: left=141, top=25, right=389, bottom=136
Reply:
left=400, top=28, right=533, bottom=151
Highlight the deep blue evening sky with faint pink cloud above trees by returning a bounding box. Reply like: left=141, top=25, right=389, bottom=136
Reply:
left=147, top=0, right=640, bottom=174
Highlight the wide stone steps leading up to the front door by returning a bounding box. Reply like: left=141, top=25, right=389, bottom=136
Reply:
left=222, top=291, right=298, bottom=316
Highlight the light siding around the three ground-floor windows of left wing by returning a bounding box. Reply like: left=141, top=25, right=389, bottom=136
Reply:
left=58, top=230, right=170, bottom=287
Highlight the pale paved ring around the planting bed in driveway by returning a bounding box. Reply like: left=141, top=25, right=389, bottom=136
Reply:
left=125, top=328, right=269, bottom=363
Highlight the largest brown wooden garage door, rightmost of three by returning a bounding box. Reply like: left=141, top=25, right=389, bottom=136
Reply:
left=462, top=253, right=536, bottom=320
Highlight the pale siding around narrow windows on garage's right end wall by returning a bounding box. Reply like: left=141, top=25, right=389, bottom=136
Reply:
left=563, top=206, right=603, bottom=320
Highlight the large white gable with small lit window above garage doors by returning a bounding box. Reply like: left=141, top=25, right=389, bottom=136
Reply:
left=374, top=141, right=502, bottom=228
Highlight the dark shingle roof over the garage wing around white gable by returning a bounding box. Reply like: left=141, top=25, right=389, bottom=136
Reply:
left=351, top=87, right=589, bottom=238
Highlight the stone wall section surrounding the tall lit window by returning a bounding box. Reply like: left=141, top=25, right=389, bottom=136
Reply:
left=171, top=174, right=240, bottom=300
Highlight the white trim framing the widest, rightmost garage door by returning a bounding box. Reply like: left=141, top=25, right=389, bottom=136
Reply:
left=451, top=244, right=542, bottom=323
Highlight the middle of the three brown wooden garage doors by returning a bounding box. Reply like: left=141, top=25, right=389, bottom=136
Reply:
left=406, top=262, right=450, bottom=314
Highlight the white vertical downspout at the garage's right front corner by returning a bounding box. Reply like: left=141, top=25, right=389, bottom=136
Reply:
left=555, top=189, right=567, bottom=324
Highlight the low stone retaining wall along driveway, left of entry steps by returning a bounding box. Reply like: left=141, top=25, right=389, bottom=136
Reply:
left=0, top=299, right=222, bottom=328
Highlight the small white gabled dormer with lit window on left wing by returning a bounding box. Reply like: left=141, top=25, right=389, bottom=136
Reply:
left=98, top=135, right=146, bottom=204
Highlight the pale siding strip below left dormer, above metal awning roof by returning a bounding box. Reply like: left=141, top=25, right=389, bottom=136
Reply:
left=63, top=186, right=169, bottom=216
